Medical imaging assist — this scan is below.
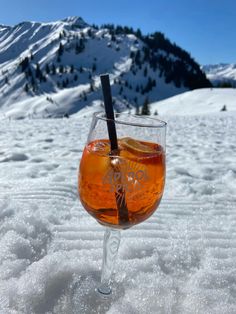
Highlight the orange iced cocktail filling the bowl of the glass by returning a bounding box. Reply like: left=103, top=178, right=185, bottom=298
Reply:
left=79, top=137, right=165, bottom=229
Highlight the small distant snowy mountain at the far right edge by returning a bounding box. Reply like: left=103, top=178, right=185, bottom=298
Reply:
left=202, top=63, right=236, bottom=87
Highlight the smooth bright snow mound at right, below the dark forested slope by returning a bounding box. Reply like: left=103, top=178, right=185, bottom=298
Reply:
left=150, top=88, right=236, bottom=115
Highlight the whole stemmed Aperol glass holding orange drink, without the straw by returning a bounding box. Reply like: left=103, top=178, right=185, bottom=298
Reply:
left=78, top=112, right=166, bottom=295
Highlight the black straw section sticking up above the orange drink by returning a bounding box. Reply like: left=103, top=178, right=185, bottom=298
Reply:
left=100, top=74, right=118, bottom=151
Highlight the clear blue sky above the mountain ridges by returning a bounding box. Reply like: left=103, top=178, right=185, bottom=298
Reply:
left=0, top=0, right=236, bottom=64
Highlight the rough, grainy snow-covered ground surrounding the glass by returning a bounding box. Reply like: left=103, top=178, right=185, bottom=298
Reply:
left=0, top=104, right=236, bottom=314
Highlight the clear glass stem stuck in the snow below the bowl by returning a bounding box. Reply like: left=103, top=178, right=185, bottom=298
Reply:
left=98, top=228, right=120, bottom=295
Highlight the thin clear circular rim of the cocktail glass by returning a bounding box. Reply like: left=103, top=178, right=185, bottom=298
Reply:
left=93, top=111, right=167, bottom=129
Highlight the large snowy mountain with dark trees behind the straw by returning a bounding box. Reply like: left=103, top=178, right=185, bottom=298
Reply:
left=0, top=17, right=210, bottom=119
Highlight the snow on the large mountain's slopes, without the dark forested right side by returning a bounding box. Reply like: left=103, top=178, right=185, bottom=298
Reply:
left=0, top=17, right=190, bottom=119
